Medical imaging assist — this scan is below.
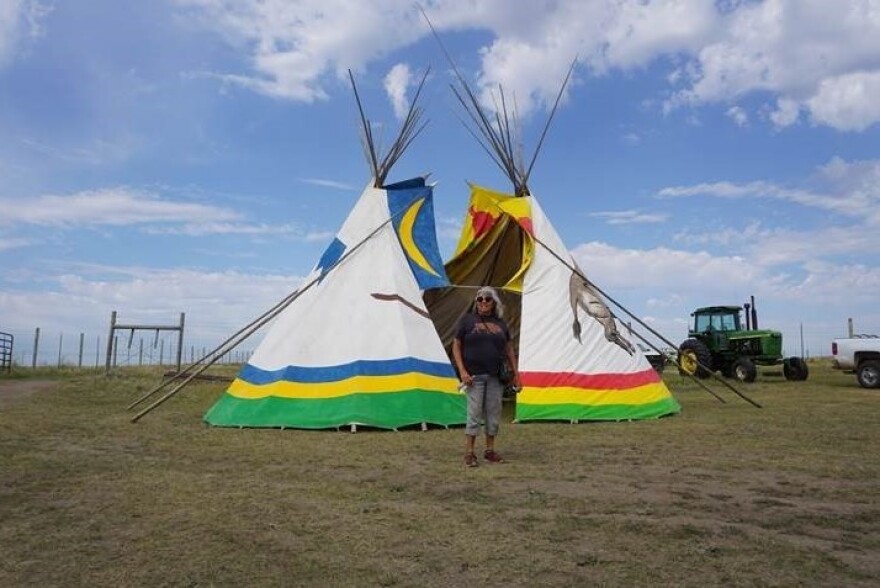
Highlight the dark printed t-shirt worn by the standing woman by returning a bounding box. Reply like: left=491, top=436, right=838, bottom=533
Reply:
left=455, top=313, right=510, bottom=375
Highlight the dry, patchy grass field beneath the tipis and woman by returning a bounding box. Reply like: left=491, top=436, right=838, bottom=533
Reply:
left=0, top=360, right=880, bottom=587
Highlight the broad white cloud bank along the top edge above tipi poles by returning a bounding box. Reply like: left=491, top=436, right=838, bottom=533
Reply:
left=177, top=0, right=880, bottom=131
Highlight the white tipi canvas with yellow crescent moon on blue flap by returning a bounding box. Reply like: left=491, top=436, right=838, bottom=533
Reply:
left=205, top=179, right=465, bottom=429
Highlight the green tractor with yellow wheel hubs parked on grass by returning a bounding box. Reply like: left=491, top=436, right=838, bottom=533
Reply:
left=678, top=297, right=809, bottom=382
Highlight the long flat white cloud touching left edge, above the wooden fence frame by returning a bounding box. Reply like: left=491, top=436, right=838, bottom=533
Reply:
left=0, top=187, right=239, bottom=226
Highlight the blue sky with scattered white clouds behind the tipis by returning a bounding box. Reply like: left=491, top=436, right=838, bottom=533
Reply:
left=0, top=0, right=880, bottom=366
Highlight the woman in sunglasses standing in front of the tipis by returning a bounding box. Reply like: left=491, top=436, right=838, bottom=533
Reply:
left=452, top=286, right=519, bottom=467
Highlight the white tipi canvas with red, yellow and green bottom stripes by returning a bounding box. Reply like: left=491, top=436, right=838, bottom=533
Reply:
left=425, top=186, right=680, bottom=422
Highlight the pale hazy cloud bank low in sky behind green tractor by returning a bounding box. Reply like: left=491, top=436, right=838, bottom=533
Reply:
left=572, top=242, right=880, bottom=355
